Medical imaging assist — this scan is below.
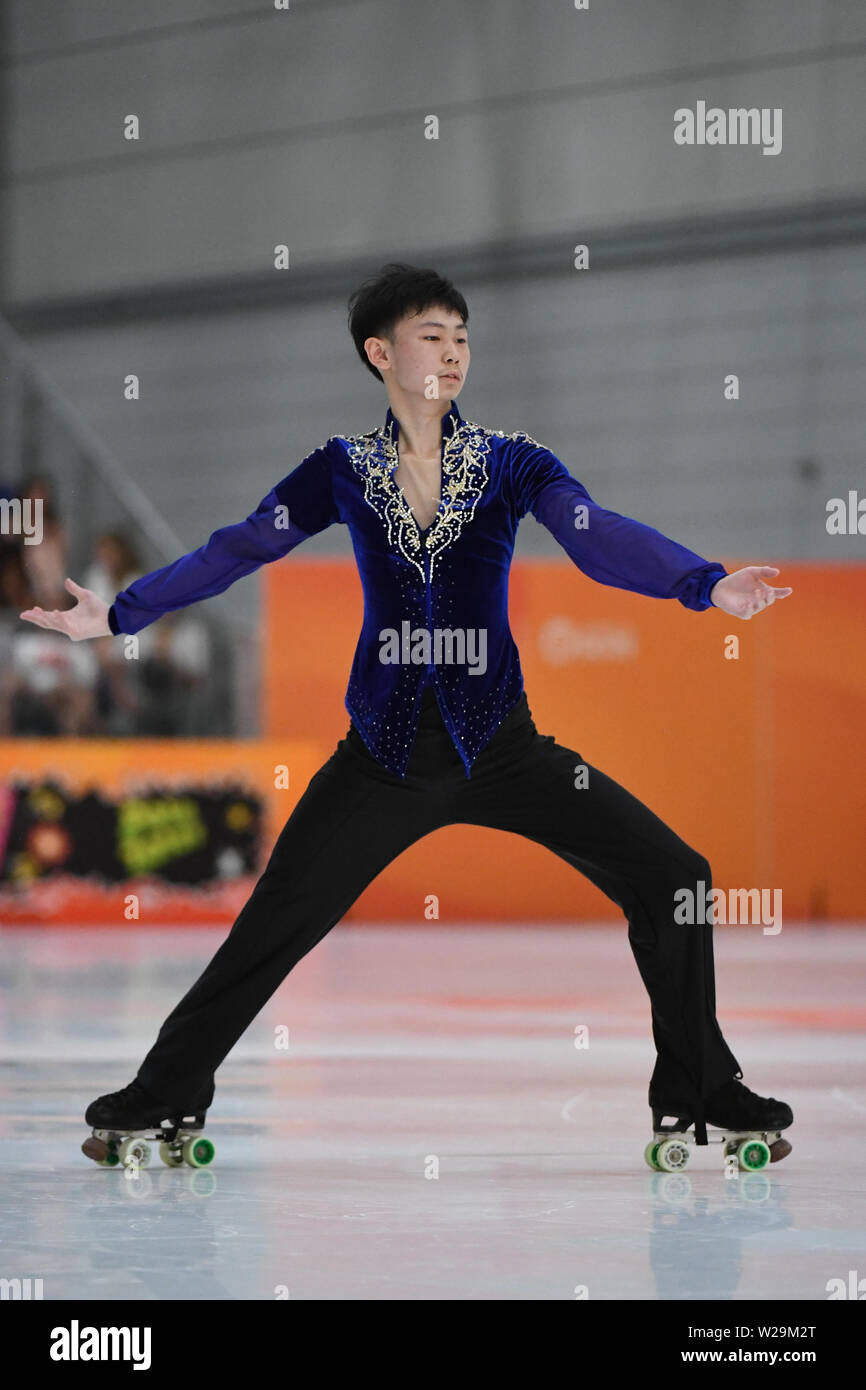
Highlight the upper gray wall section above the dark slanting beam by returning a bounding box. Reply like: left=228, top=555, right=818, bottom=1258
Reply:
left=4, top=0, right=866, bottom=300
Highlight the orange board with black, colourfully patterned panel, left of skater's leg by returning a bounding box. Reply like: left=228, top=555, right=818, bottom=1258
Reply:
left=0, top=738, right=321, bottom=927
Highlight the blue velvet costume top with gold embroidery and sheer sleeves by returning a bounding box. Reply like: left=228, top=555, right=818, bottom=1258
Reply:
left=108, top=402, right=727, bottom=777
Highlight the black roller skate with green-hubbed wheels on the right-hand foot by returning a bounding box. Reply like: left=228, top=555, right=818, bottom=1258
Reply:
left=644, top=1079, right=794, bottom=1176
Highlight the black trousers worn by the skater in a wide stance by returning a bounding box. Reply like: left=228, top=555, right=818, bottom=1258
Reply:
left=138, top=687, right=741, bottom=1143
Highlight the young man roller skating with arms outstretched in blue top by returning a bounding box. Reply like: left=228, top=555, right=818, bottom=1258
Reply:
left=21, top=263, right=794, bottom=1162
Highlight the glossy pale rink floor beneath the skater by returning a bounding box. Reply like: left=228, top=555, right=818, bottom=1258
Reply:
left=0, top=922, right=866, bottom=1301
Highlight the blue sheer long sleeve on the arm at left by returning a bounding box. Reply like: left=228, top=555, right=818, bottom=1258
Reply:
left=108, top=441, right=339, bottom=634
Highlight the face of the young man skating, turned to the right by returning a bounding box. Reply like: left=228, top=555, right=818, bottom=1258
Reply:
left=364, top=307, right=470, bottom=400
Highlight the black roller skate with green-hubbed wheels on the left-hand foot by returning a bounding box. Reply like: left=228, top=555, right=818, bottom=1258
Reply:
left=81, top=1080, right=214, bottom=1168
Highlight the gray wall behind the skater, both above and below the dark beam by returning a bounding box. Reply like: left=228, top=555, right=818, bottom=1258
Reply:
left=1, top=0, right=866, bottom=636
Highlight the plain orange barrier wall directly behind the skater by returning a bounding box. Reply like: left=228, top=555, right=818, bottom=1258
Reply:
left=263, top=556, right=866, bottom=923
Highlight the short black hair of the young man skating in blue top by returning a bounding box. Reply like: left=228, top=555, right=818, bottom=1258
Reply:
left=349, top=261, right=468, bottom=381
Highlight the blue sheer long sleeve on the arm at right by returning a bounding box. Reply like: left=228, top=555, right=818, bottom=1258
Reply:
left=510, top=435, right=727, bottom=612
